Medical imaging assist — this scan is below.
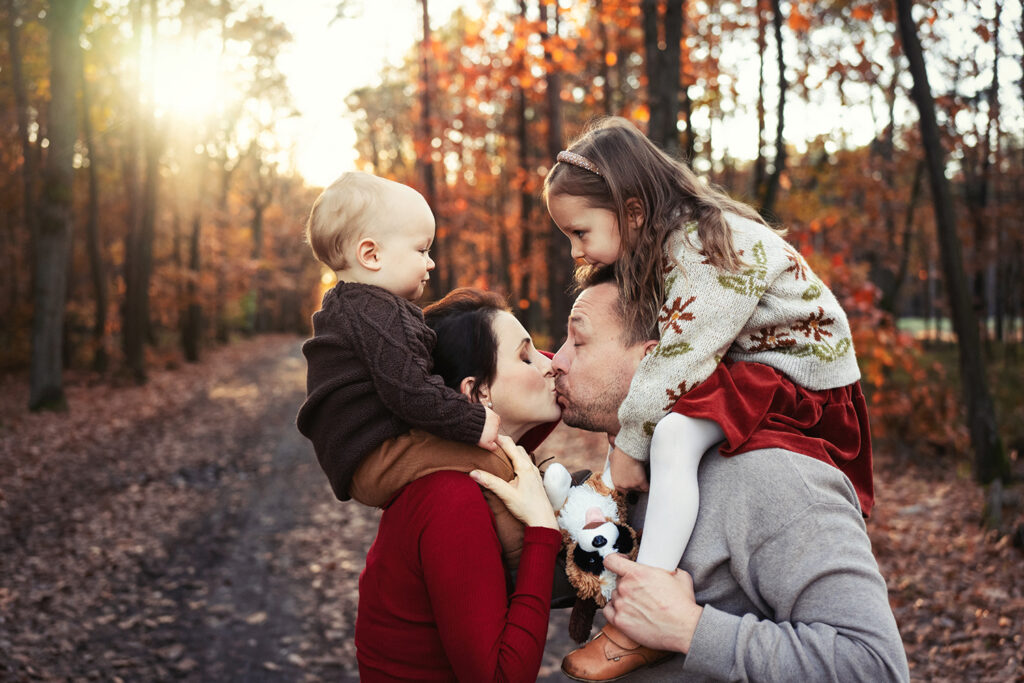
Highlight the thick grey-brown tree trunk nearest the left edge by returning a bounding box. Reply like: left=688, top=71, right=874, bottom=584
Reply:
left=29, top=0, right=85, bottom=411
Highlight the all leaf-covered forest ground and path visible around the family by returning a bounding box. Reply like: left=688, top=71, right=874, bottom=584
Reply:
left=0, top=336, right=1024, bottom=681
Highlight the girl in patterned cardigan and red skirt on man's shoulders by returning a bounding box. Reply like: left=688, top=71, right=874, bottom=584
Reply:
left=544, top=118, right=873, bottom=680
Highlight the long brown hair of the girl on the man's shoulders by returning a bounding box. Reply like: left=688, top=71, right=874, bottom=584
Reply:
left=544, top=117, right=765, bottom=342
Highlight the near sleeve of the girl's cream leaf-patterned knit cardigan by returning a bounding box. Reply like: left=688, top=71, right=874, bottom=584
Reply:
left=615, top=230, right=768, bottom=461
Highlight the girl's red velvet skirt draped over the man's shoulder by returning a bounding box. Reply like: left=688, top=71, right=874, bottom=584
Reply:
left=672, top=359, right=874, bottom=517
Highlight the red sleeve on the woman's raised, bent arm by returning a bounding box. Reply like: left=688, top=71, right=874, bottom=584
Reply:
left=420, top=472, right=561, bottom=681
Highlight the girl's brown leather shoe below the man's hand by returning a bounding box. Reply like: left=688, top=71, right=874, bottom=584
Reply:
left=562, top=624, right=673, bottom=682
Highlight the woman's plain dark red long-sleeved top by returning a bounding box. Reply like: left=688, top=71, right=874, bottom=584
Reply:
left=355, top=471, right=562, bottom=683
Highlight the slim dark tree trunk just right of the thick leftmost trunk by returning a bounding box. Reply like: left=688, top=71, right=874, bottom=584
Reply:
left=79, top=44, right=109, bottom=373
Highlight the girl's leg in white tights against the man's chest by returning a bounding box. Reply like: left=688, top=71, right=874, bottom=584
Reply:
left=637, top=413, right=725, bottom=571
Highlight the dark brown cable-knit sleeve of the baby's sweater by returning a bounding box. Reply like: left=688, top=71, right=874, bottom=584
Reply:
left=338, top=288, right=486, bottom=443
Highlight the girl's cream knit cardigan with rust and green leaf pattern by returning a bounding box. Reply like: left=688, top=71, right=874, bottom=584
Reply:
left=615, top=214, right=860, bottom=461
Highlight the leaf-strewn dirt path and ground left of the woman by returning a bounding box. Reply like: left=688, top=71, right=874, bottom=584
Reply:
left=0, top=337, right=589, bottom=681
